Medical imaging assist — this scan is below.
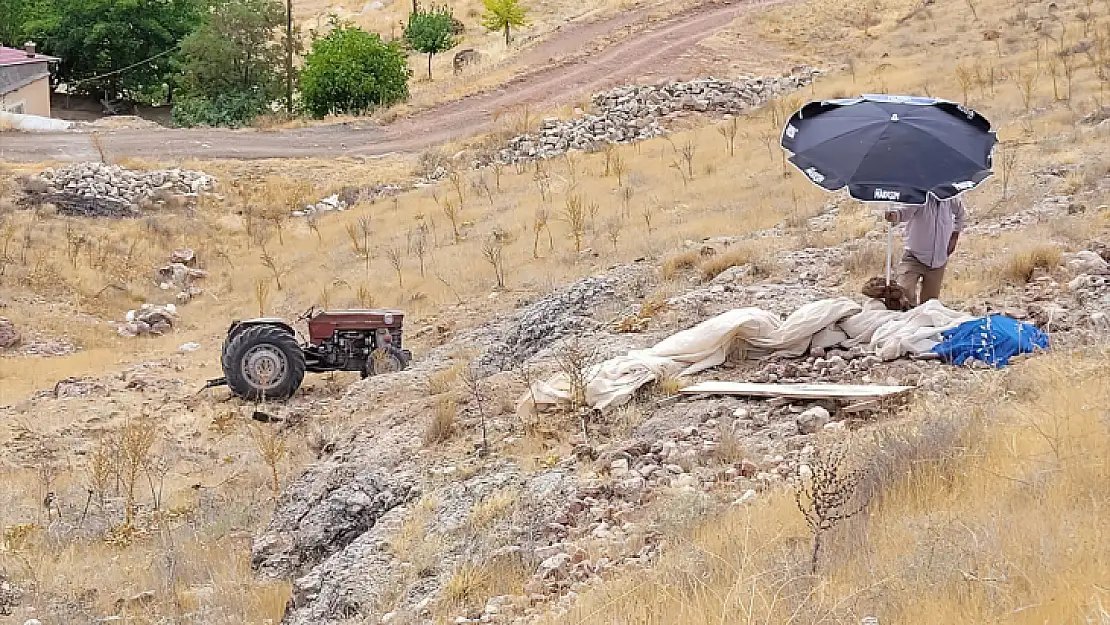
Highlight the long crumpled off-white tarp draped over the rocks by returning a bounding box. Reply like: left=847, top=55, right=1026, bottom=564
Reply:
left=522, top=298, right=973, bottom=410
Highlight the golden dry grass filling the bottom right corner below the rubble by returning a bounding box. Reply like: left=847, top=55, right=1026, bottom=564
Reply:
left=552, top=353, right=1110, bottom=625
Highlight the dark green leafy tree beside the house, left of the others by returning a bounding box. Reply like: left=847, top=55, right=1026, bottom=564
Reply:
left=23, top=0, right=201, bottom=101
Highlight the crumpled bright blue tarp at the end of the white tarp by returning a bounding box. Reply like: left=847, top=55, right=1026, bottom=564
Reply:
left=932, top=314, right=1048, bottom=367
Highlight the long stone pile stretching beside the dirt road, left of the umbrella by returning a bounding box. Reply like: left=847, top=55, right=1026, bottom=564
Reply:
left=498, top=68, right=819, bottom=163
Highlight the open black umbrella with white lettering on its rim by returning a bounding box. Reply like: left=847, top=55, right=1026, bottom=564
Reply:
left=781, top=95, right=997, bottom=204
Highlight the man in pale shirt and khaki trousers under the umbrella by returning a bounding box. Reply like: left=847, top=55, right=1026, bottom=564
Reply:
left=887, top=193, right=965, bottom=306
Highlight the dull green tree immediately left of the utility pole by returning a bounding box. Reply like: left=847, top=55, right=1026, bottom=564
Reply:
left=174, top=0, right=285, bottom=125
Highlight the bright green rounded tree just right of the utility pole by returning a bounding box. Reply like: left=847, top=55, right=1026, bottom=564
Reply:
left=301, top=23, right=408, bottom=118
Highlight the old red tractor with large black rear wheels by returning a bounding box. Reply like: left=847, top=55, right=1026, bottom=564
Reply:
left=205, top=306, right=412, bottom=401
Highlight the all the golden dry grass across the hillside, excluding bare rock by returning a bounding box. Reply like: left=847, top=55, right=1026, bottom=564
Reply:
left=0, top=0, right=1110, bottom=624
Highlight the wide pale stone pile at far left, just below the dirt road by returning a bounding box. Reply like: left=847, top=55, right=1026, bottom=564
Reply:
left=27, top=162, right=215, bottom=216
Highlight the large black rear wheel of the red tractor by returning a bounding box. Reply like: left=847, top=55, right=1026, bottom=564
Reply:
left=221, top=325, right=304, bottom=402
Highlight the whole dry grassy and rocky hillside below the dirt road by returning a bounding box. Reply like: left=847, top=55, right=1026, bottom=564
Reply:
left=0, top=0, right=1110, bottom=625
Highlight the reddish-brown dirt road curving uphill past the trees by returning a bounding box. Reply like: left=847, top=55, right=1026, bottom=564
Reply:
left=0, top=0, right=786, bottom=161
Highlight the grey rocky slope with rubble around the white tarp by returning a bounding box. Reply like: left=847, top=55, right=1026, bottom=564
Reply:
left=247, top=197, right=1110, bottom=625
